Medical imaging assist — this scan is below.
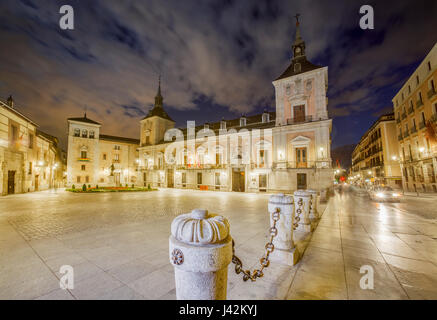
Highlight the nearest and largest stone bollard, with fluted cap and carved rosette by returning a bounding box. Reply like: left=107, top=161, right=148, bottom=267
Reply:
left=169, top=209, right=232, bottom=300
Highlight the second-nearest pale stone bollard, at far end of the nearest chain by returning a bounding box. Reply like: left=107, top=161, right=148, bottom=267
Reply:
left=268, top=194, right=299, bottom=266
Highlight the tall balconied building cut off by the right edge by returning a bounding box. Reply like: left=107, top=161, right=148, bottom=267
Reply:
left=392, top=43, right=437, bottom=192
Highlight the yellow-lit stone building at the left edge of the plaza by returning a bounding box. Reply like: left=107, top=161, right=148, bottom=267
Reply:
left=0, top=97, right=64, bottom=195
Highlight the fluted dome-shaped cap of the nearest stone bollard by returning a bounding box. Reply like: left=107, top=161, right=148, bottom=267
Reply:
left=171, top=209, right=230, bottom=245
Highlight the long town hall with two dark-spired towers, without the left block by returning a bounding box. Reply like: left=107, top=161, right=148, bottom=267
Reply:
left=138, top=19, right=333, bottom=192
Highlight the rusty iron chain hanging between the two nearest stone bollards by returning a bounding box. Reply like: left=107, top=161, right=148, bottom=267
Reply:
left=232, top=208, right=281, bottom=282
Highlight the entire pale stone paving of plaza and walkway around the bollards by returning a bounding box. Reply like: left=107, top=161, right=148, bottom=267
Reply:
left=0, top=190, right=437, bottom=299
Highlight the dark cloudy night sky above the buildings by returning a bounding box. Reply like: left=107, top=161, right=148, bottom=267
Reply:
left=0, top=0, right=437, bottom=147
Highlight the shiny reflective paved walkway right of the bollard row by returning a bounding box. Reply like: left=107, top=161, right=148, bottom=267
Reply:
left=287, top=194, right=437, bottom=300
